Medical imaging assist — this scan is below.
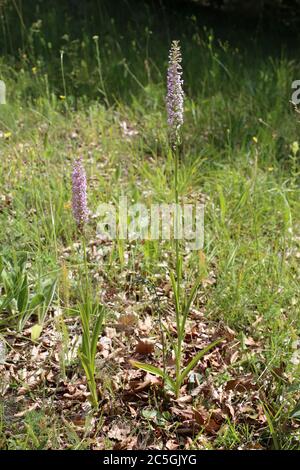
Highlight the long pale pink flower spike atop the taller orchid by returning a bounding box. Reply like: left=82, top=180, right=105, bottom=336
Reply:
left=166, top=41, right=184, bottom=145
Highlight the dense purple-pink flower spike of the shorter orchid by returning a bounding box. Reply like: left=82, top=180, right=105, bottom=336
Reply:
left=72, top=157, right=89, bottom=229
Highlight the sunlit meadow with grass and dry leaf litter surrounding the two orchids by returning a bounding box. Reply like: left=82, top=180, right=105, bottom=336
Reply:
left=0, top=0, right=300, bottom=449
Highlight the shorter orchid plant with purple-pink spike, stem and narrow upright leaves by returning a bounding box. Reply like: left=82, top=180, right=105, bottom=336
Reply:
left=72, top=157, right=104, bottom=408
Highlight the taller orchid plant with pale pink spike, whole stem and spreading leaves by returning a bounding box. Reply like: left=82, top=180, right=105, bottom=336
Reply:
left=133, top=41, right=221, bottom=397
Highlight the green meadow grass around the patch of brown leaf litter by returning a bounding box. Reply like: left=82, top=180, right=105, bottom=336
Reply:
left=0, top=2, right=300, bottom=449
